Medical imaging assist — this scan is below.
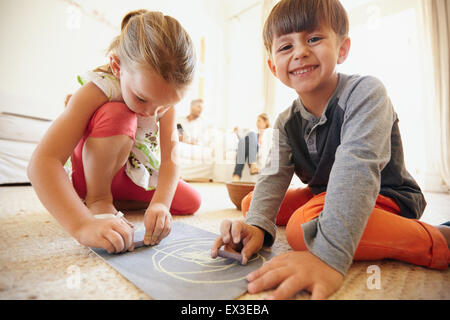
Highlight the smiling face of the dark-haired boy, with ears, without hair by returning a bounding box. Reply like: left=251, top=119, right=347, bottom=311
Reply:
left=268, top=27, right=350, bottom=97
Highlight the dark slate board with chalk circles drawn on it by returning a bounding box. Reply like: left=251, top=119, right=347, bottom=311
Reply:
left=91, top=221, right=274, bottom=300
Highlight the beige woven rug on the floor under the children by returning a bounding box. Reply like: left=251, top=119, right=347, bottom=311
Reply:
left=0, top=183, right=450, bottom=299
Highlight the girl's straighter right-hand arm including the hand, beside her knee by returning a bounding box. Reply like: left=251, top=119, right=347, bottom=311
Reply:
left=144, top=107, right=180, bottom=245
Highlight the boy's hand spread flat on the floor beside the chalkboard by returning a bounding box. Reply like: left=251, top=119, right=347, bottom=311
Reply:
left=247, top=251, right=344, bottom=300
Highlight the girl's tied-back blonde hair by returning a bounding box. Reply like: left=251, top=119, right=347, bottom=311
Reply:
left=108, top=9, right=196, bottom=88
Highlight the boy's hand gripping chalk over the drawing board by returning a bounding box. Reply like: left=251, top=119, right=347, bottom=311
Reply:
left=211, top=220, right=264, bottom=264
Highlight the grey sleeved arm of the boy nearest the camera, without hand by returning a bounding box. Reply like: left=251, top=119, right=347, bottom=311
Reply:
left=302, top=78, right=395, bottom=274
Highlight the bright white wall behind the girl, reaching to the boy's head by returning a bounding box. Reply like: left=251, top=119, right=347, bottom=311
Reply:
left=0, top=0, right=263, bottom=128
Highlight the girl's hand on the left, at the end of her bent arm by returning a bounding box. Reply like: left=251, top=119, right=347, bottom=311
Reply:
left=74, top=217, right=134, bottom=253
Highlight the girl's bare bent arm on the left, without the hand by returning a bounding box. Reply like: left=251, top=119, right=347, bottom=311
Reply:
left=28, top=83, right=108, bottom=236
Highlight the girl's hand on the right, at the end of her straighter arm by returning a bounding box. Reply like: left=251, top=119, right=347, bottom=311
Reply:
left=144, top=203, right=172, bottom=246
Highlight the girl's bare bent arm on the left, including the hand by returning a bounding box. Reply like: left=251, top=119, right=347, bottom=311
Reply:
left=28, top=83, right=133, bottom=252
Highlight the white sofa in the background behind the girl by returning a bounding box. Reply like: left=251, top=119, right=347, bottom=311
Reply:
left=0, top=112, right=257, bottom=185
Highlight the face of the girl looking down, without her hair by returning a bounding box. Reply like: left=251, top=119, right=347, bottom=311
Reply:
left=113, top=57, right=182, bottom=117
